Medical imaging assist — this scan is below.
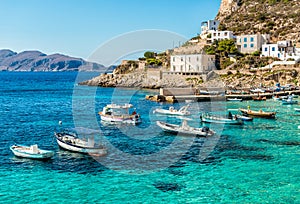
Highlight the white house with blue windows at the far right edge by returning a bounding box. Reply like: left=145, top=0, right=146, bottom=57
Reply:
left=261, top=40, right=300, bottom=61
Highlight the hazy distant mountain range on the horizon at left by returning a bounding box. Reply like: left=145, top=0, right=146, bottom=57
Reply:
left=0, top=50, right=114, bottom=72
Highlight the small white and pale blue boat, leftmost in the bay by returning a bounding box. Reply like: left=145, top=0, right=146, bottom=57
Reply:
left=10, top=144, right=54, bottom=159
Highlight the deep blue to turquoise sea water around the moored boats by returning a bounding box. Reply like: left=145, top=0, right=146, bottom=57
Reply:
left=0, top=72, right=300, bottom=203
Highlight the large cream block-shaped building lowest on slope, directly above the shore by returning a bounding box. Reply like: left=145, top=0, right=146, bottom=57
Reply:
left=170, top=54, right=216, bottom=74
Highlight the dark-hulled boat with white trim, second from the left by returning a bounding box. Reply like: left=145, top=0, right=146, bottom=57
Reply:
left=54, top=128, right=107, bottom=156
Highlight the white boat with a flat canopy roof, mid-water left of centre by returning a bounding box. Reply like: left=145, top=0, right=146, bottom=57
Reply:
left=99, top=104, right=142, bottom=125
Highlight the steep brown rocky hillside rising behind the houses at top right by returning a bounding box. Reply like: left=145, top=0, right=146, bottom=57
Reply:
left=216, top=0, right=300, bottom=42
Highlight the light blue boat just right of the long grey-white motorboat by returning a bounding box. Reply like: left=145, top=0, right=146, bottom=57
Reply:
left=200, top=113, right=243, bottom=125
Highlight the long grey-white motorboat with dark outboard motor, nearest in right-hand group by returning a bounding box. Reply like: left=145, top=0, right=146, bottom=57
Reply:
left=156, top=120, right=215, bottom=137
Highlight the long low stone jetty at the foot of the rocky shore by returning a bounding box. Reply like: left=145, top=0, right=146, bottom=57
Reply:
left=146, top=88, right=300, bottom=103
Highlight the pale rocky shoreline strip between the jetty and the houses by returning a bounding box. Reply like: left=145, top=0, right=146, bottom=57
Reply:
left=80, top=66, right=300, bottom=89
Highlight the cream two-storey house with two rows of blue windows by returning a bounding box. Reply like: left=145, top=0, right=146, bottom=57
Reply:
left=236, top=34, right=270, bottom=53
